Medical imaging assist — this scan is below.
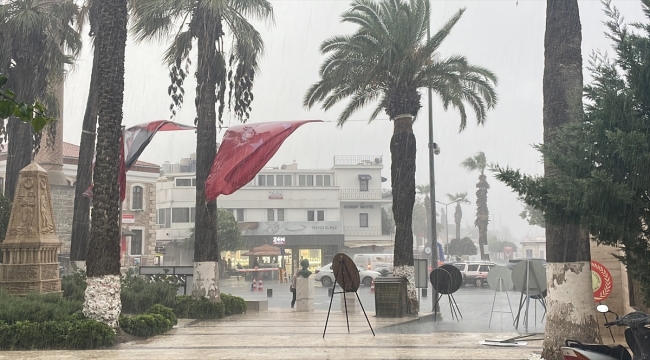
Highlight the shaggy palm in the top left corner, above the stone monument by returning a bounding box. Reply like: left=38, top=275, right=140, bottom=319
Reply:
left=0, top=0, right=81, bottom=200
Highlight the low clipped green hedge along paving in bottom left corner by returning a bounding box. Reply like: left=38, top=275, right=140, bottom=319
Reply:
left=0, top=320, right=115, bottom=350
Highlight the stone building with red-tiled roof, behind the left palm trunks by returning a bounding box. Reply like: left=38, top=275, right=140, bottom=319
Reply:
left=0, top=142, right=160, bottom=265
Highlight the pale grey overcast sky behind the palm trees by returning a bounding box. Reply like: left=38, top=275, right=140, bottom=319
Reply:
left=64, top=0, right=644, bottom=241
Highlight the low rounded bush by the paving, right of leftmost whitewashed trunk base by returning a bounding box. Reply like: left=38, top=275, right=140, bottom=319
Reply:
left=120, top=305, right=177, bottom=337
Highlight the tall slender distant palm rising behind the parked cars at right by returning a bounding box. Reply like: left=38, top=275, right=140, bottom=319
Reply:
left=460, top=151, right=490, bottom=260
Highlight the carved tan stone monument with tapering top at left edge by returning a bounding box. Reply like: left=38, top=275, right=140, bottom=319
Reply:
left=0, top=162, right=61, bottom=295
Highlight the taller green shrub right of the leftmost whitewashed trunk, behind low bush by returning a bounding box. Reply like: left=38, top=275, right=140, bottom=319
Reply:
left=121, top=270, right=178, bottom=314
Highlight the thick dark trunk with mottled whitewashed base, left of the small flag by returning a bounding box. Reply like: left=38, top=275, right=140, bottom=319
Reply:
left=83, top=0, right=128, bottom=328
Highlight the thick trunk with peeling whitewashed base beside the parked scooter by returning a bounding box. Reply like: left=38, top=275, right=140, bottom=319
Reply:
left=542, top=0, right=600, bottom=360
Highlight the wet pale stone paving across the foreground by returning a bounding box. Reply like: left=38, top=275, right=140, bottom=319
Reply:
left=0, top=309, right=541, bottom=360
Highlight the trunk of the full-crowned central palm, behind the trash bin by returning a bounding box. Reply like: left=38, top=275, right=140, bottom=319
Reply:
left=390, top=115, right=418, bottom=314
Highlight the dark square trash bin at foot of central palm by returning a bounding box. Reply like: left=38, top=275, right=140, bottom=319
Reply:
left=375, top=276, right=408, bottom=318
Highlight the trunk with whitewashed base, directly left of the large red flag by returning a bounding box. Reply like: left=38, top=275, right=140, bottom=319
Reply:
left=192, top=9, right=221, bottom=301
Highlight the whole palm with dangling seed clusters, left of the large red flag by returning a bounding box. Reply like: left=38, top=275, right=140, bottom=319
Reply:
left=131, top=0, right=273, bottom=301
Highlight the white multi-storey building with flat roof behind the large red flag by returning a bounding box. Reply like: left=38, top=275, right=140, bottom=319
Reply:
left=156, top=156, right=393, bottom=268
